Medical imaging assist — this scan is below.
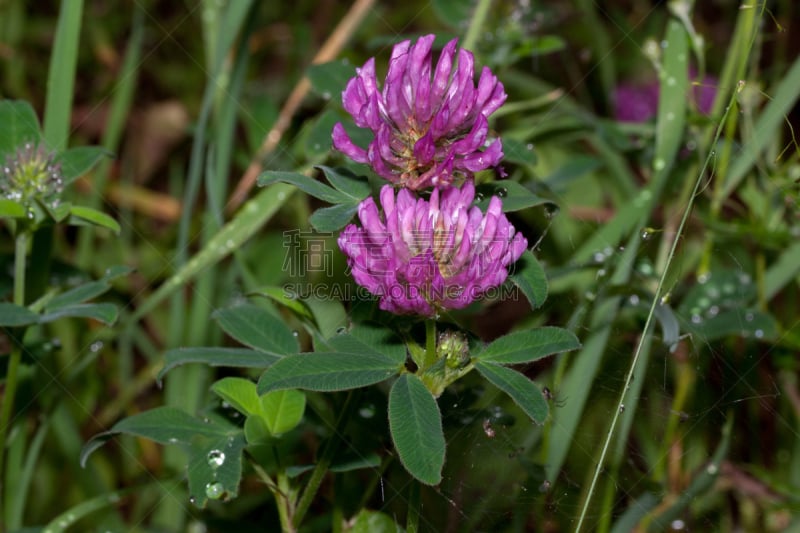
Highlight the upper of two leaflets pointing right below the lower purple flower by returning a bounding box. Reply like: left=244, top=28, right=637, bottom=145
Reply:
left=476, top=327, right=581, bottom=365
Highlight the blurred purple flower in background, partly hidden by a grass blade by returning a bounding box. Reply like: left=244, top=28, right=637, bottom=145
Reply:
left=613, top=68, right=718, bottom=122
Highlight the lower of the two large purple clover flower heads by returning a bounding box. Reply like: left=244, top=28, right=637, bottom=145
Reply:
left=339, top=180, right=528, bottom=317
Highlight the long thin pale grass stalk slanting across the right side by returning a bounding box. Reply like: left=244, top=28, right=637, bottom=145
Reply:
left=575, top=87, right=730, bottom=533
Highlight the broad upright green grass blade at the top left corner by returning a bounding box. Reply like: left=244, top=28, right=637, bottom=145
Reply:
left=43, top=0, right=83, bottom=150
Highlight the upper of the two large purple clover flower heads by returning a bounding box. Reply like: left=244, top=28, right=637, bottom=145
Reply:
left=333, top=35, right=506, bottom=190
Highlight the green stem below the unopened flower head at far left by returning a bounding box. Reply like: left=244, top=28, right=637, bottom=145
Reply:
left=0, top=230, right=30, bottom=531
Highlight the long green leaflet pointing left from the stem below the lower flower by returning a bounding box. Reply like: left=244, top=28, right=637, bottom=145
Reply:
left=258, top=352, right=401, bottom=394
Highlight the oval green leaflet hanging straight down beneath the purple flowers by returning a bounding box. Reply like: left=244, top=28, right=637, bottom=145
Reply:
left=389, top=374, right=445, bottom=485
